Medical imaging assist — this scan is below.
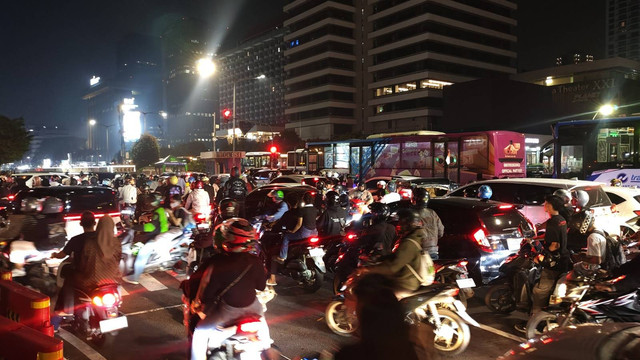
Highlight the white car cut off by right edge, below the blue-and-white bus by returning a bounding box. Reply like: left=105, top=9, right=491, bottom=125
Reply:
left=603, top=186, right=640, bottom=236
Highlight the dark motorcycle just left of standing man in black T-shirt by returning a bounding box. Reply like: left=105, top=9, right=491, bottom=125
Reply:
left=484, top=239, right=542, bottom=314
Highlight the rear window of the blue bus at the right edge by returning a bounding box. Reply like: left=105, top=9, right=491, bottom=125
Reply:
left=596, top=127, right=635, bottom=164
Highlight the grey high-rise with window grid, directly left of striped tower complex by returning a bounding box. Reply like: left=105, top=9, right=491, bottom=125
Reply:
left=216, top=27, right=285, bottom=136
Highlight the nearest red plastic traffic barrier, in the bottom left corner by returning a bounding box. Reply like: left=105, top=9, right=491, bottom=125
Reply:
left=0, top=316, right=64, bottom=360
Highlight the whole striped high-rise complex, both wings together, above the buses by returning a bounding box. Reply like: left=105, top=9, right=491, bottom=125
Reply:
left=284, top=0, right=517, bottom=139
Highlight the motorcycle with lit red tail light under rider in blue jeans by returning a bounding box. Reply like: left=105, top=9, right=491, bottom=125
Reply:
left=254, top=222, right=327, bottom=293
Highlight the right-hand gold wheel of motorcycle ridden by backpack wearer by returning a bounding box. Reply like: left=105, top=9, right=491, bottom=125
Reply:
left=431, top=309, right=471, bottom=356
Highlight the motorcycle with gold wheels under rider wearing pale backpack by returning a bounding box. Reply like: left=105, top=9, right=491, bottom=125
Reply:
left=325, top=274, right=479, bottom=356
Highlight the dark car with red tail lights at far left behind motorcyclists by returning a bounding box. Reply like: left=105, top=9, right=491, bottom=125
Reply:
left=13, top=186, right=121, bottom=239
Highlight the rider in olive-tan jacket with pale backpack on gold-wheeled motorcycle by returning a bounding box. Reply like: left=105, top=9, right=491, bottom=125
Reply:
left=365, top=208, right=433, bottom=296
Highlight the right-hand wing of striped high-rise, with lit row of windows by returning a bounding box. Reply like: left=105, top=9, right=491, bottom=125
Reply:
left=365, top=0, right=517, bottom=133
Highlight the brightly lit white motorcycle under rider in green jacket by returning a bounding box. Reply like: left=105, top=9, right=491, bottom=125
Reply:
left=120, top=228, right=191, bottom=275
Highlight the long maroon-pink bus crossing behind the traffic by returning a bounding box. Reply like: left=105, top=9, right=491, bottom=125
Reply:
left=306, top=131, right=526, bottom=184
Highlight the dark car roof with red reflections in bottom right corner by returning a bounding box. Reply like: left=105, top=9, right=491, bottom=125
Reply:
left=498, top=322, right=640, bottom=360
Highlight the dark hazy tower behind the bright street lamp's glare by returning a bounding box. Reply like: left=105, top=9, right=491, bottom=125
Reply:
left=162, top=18, right=217, bottom=145
